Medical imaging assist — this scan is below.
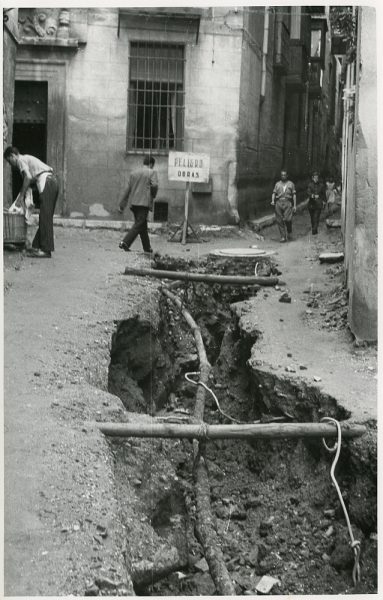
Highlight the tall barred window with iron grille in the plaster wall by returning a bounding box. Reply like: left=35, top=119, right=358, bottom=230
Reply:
left=127, top=42, right=185, bottom=152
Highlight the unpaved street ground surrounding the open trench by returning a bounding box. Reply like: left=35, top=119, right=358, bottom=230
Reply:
left=4, top=213, right=377, bottom=596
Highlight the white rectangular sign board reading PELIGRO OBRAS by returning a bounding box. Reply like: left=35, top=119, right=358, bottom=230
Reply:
left=168, top=152, right=210, bottom=183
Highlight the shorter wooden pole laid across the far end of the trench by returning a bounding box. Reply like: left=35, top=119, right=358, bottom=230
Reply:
left=125, top=267, right=279, bottom=286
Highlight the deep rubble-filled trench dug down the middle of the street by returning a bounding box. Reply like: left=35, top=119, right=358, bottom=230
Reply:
left=108, top=257, right=377, bottom=595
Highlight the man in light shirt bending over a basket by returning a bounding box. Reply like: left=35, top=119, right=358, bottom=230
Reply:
left=4, top=146, right=59, bottom=258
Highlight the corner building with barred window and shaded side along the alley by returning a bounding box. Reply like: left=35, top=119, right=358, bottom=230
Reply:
left=6, top=6, right=336, bottom=224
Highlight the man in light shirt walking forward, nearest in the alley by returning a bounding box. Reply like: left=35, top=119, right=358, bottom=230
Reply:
left=271, top=170, right=297, bottom=242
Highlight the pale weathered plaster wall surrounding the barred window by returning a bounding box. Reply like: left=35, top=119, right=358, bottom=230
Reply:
left=62, top=8, right=241, bottom=223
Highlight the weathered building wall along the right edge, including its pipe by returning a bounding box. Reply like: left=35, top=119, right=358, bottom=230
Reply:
left=343, top=6, right=378, bottom=342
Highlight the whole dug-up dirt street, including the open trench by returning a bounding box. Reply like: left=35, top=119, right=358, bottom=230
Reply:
left=4, top=213, right=377, bottom=596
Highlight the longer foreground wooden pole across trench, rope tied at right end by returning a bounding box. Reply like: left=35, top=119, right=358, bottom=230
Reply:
left=97, top=422, right=366, bottom=440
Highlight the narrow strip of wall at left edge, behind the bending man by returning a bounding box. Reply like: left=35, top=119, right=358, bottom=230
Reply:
left=3, top=8, right=18, bottom=206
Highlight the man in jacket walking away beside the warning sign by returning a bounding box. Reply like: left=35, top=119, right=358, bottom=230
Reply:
left=118, top=155, right=158, bottom=254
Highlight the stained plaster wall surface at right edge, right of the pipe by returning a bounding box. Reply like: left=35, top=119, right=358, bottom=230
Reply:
left=346, top=7, right=378, bottom=341
